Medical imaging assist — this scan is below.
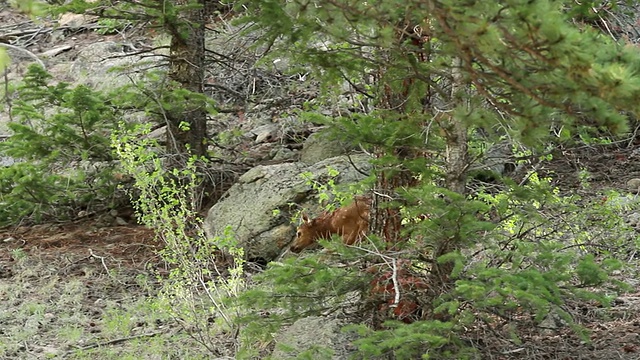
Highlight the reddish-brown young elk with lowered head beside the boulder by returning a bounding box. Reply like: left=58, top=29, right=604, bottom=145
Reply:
left=290, top=196, right=371, bottom=253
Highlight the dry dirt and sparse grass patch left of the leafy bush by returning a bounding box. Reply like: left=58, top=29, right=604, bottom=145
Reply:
left=0, top=221, right=164, bottom=359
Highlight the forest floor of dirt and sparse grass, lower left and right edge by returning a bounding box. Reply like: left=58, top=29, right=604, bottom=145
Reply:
left=0, top=149, right=640, bottom=360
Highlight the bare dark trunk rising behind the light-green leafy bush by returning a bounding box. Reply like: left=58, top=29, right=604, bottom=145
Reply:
left=166, top=0, right=207, bottom=155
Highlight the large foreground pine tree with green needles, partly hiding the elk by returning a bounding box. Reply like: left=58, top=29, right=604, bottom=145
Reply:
left=241, top=0, right=640, bottom=358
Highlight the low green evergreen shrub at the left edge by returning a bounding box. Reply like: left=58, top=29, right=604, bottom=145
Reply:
left=0, top=65, right=122, bottom=225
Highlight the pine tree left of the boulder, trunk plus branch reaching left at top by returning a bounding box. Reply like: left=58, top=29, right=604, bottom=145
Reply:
left=56, top=0, right=215, bottom=156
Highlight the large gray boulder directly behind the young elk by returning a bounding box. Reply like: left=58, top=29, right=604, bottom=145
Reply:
left=204, top=155, right=371, bottom=261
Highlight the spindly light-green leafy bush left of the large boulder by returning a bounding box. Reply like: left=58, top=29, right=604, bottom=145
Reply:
left=111, top=125, right=245, bottom=354
